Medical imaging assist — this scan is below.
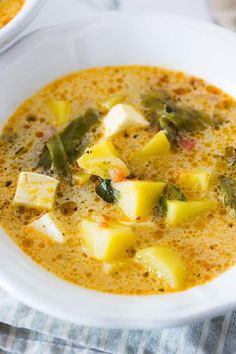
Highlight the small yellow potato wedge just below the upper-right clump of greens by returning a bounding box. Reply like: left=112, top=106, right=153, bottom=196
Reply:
left=135, top=130, right=170, bottom=158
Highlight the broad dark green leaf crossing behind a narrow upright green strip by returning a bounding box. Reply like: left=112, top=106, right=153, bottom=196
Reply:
left=38, top=110, right=98, bottom=171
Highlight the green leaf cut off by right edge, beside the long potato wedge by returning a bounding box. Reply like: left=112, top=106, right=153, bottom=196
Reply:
left=219, top=176, right=236, bottom=212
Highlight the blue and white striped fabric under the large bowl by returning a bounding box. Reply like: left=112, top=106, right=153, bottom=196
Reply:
left=0, top=290, right=236, bottom=354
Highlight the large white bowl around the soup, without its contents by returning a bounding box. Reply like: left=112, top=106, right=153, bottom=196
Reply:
left=0, top=14, right=236, bottom=328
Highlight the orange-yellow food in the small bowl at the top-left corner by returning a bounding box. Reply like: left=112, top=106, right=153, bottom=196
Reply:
left=0, top=0, right=25, bottom=29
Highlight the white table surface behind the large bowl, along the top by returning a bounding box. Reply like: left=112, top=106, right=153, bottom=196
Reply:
left=24, top=0, right=213, bottom=37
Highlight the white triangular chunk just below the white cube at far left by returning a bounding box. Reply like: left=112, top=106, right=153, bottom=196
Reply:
left=26, top=213, right=64, bottom=243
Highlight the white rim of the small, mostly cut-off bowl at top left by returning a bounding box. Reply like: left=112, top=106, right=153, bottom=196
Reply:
left=0, top=0, right=45, bottom=53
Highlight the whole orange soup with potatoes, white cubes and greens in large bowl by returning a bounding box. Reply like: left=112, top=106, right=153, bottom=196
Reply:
left=0, top=66, right=236, bottom=295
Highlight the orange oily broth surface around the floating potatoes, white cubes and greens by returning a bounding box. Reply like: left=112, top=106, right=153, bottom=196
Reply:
left=0, top=66, right=236, bottom=294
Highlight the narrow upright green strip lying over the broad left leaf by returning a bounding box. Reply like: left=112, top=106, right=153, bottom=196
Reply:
left=47, top=134, right=72, bottom=183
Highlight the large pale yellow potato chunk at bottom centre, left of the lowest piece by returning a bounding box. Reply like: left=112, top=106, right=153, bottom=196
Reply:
left=80, top=219, right=135, bottom=261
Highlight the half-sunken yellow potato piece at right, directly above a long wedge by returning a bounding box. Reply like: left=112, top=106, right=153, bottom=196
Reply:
left=179, top=168, right=212, bottom=191
